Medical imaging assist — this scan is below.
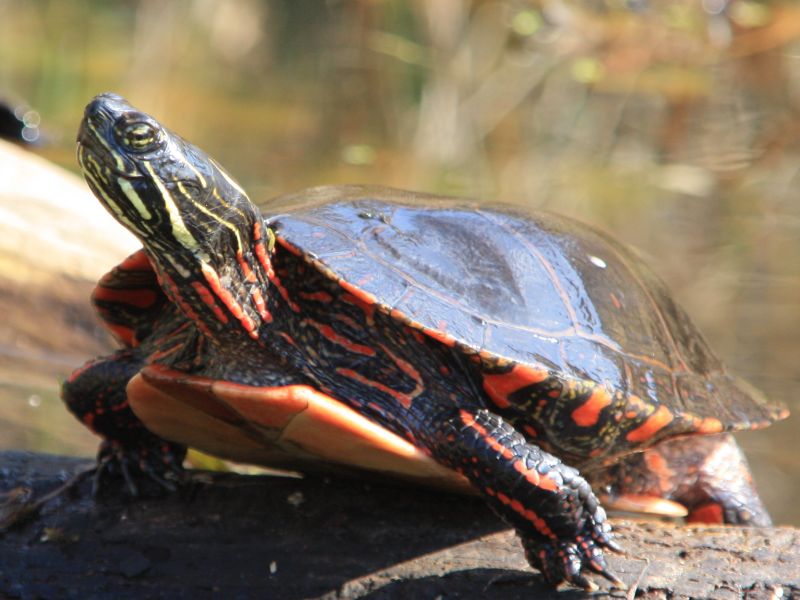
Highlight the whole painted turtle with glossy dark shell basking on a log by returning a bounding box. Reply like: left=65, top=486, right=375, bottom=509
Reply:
left=63, top=94, right=786, bottom=588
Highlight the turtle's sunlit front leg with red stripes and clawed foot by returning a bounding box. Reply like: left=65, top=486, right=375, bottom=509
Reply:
left=429, top=409, right=622, bottom=590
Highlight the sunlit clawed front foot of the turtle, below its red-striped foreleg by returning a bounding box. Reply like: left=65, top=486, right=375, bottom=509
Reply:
left=522, top=508, right=626, bottom=592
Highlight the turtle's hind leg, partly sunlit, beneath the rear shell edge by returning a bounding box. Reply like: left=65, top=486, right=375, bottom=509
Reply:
left=590, top=434, right=772, bottom=526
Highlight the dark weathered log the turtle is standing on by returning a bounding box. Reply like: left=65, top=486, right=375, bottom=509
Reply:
left=0, top=452, right=800, bottom=600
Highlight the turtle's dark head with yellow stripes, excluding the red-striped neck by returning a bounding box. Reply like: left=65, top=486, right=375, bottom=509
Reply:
left=78, top=94, right=260, bottom=257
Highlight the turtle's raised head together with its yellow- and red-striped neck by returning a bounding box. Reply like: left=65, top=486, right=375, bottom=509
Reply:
left=78, top=94, right=271, bottom=337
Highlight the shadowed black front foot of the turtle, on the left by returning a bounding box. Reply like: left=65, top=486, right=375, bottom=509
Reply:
left=92, top=436, right=186, bottom=498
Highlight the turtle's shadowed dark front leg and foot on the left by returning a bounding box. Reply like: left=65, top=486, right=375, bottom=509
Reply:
left=61, top=349, right=186, bottom=496
